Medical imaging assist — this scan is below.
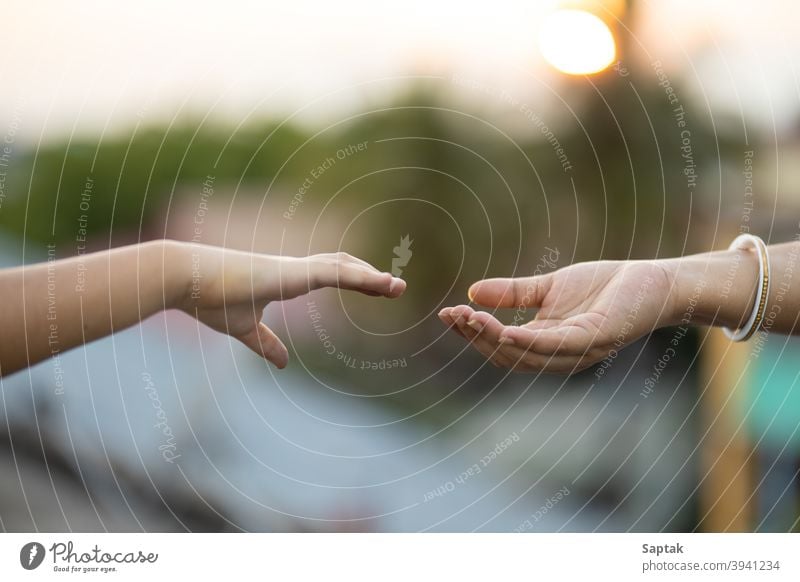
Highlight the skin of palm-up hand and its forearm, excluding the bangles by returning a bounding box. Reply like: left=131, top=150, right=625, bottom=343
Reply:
left=439, top=242, right=800, bottom=374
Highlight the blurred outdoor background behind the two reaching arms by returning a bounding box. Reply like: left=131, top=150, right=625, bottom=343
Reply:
left=0, top=0, right=800, bottom=532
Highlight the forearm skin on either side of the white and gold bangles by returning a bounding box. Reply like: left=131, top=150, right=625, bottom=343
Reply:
left=663, top=241, right=800, bottom=334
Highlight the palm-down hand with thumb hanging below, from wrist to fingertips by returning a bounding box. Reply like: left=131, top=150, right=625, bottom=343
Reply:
left=172, top=244, right=406, bottom=368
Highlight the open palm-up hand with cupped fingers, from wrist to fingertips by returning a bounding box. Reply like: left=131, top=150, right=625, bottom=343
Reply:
left=439, top=261, right=676, bottom=374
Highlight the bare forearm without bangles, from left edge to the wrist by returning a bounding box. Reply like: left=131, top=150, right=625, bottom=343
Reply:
left=0, top=241, right=184, bottom=375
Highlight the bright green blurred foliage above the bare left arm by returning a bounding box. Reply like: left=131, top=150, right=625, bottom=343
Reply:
left=0, top=123, right=312, bottom=243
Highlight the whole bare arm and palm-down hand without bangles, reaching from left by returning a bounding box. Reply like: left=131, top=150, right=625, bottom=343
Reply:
left=0, top=240, right=406, bottom=376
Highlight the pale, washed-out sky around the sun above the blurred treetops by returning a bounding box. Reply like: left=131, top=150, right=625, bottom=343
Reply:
left=0, top=0, right=800, bottom=142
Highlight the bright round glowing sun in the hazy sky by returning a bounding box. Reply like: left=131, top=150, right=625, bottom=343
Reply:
left=539, top=10, right=617, bottom=75
